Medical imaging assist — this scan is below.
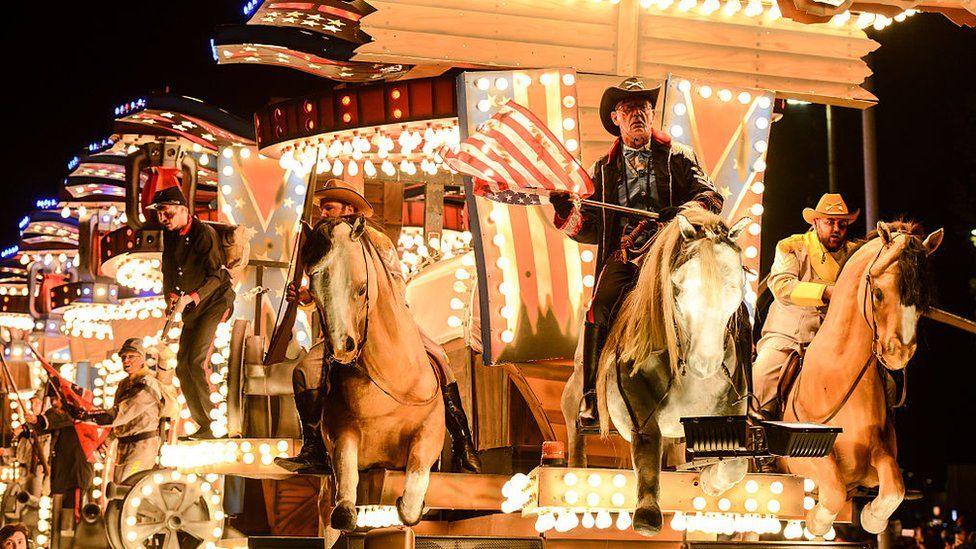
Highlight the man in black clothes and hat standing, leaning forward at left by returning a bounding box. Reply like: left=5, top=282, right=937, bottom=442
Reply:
left=148, top=187, right=234, bottom=439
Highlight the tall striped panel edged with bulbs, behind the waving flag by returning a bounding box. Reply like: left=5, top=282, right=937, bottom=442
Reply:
left=454, top=69, right=595, bottom=364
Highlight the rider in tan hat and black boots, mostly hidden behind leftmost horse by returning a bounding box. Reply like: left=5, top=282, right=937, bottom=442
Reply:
left=275, top=179, right=481, bottom=475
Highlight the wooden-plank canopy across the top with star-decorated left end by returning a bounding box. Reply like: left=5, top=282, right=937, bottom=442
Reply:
left=214, top=0, right=976, bottom=107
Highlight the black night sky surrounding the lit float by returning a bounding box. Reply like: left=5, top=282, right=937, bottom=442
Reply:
left=0, top=0, right=976, bottom=491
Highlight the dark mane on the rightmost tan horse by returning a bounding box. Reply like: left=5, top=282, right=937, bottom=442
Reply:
left=842, top=219, right=935, bottom=311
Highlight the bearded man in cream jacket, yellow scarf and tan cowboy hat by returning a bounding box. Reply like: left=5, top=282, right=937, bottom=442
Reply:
left=752, top=194, right=860, bottom=419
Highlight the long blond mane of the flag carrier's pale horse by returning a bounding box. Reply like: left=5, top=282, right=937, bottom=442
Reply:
left=598, top=208, right=727, bottom=379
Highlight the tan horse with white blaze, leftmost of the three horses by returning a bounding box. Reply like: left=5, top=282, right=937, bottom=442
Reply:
left=302, top=217, right=444, bottom=531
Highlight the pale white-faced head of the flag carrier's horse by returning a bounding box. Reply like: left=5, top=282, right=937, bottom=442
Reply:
left=670, top=215, right=749, bottom=378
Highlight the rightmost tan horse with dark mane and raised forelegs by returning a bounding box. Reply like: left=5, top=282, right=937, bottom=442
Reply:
left=785, top=222, right=942, bottom=535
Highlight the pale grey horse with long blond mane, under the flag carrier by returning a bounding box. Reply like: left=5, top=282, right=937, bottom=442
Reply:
left=562, top=208, right=749, bottom=536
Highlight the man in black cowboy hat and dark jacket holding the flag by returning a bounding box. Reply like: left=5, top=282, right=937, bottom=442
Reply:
left=550, top=78, right=723, bottom=428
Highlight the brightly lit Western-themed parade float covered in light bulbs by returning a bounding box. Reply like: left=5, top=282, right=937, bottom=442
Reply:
left=0, top=0, right=976, bottom=548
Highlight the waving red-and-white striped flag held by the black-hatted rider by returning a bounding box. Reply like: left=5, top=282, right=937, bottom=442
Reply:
left=442, top=101, right=593, bottom=205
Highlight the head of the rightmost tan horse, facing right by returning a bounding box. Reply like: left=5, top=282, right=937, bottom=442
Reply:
left=859, top=221, right=943, bottom=370
